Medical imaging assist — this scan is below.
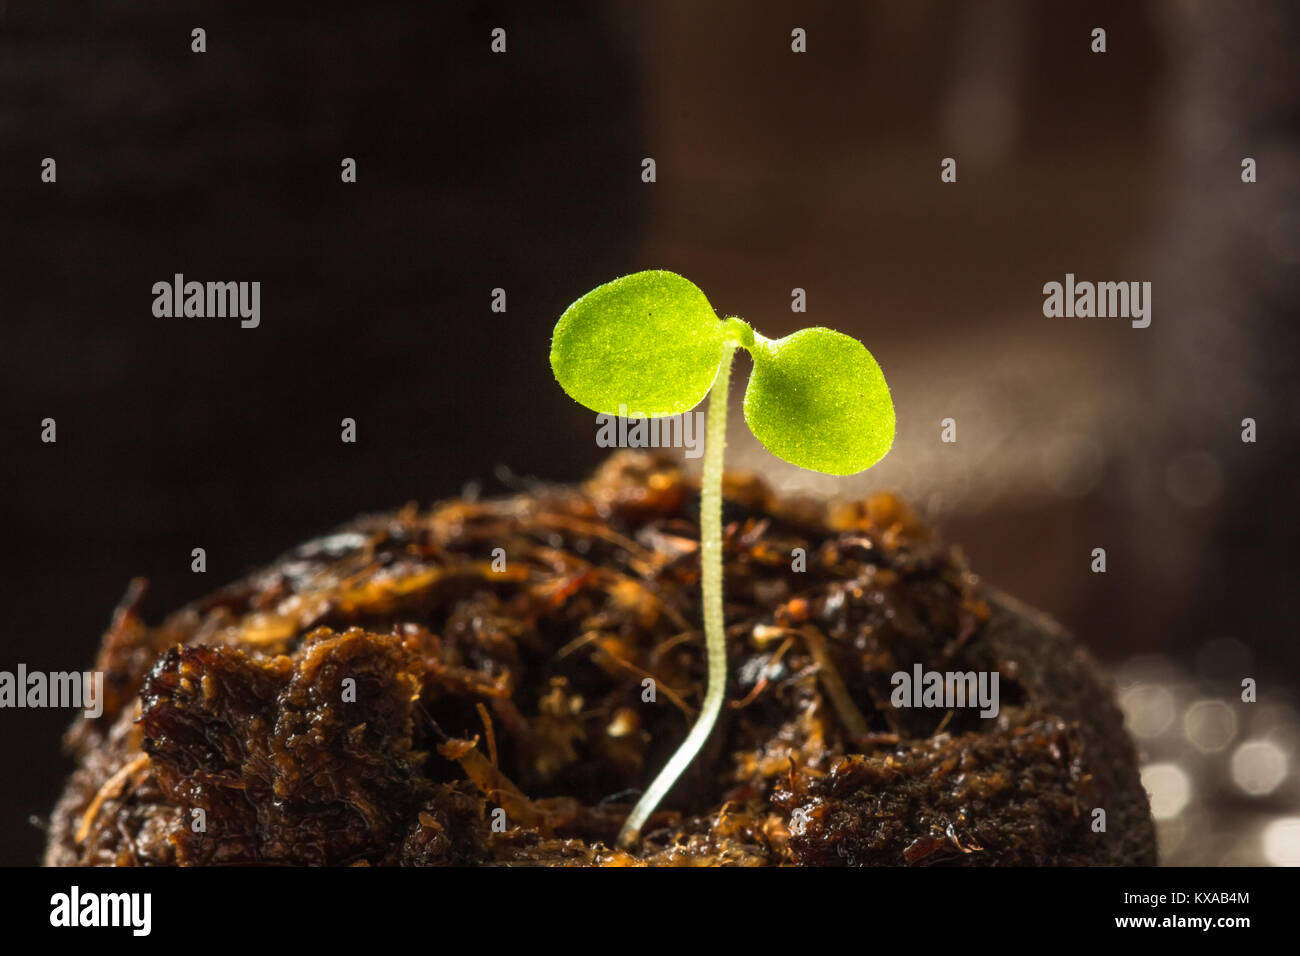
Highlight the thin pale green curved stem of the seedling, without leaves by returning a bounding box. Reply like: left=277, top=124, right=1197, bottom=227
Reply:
left=619, top=339, right=737, bottom=847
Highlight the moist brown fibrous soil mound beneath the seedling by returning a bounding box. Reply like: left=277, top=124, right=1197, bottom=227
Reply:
left=46, top=453, right=1156, bottom=866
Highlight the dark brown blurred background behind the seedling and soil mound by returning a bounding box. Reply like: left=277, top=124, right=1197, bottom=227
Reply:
left=0, top=0, right=1300, bottom=865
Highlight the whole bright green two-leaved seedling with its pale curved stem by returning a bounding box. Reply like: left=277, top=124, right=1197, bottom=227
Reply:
left=551, top=271, right=894, bottom=847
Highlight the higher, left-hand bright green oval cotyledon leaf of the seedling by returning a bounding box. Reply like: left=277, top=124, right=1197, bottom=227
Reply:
left=551, top=269, right=723, bottom=418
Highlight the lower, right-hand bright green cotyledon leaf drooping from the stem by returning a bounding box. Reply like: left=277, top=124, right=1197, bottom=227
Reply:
left=745, top=328, right=894, bottom=475
